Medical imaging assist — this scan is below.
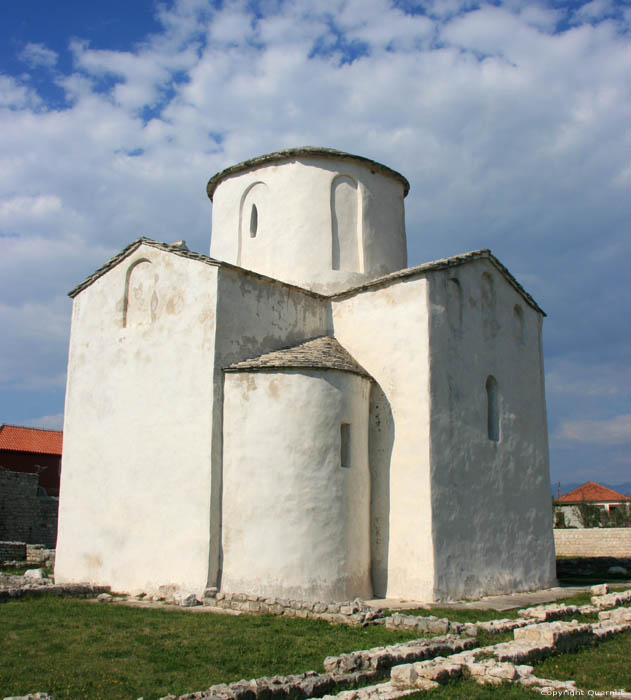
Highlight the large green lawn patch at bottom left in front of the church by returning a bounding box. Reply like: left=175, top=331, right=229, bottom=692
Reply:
left=0, top=596, right=418, bottom=700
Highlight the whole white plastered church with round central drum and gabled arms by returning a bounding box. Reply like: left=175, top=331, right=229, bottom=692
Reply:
left=55, top=147, right=555, bottom=601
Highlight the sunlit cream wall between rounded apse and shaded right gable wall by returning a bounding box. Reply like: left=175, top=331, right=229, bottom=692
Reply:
left=332, top=278, right=434, bottom=600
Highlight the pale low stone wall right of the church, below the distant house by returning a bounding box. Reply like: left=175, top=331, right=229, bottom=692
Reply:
left=554, top=527, right=631, bottom=557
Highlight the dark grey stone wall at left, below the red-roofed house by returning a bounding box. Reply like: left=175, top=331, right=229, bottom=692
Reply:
left=0, top=470, right=59, bottom=548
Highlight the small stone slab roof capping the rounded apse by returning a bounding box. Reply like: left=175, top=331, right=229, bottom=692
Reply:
left=224, top=335, right=371, bottom=379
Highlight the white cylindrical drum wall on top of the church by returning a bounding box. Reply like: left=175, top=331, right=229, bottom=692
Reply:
left=210, top=157, right=407, bottom=291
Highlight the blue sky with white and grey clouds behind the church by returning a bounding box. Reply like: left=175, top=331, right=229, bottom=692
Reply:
left=0, top=0, right=631, bottom=484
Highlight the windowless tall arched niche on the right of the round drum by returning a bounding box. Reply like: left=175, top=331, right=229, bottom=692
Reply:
left=331, top=175, right=363, bottom=272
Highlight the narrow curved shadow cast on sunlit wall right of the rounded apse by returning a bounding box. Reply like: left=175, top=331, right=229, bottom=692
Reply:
left=368, top=382, right=394, bottom=598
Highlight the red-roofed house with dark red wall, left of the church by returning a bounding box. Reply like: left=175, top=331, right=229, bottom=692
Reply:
left=0, top=424, right=63, bottom=497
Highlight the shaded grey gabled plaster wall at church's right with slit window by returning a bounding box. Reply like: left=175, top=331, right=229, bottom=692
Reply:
left=429, top=261, right=555, bottom=599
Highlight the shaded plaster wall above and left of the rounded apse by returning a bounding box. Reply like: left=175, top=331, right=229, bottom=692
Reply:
left=208, top=267, right=330, bottom=586
